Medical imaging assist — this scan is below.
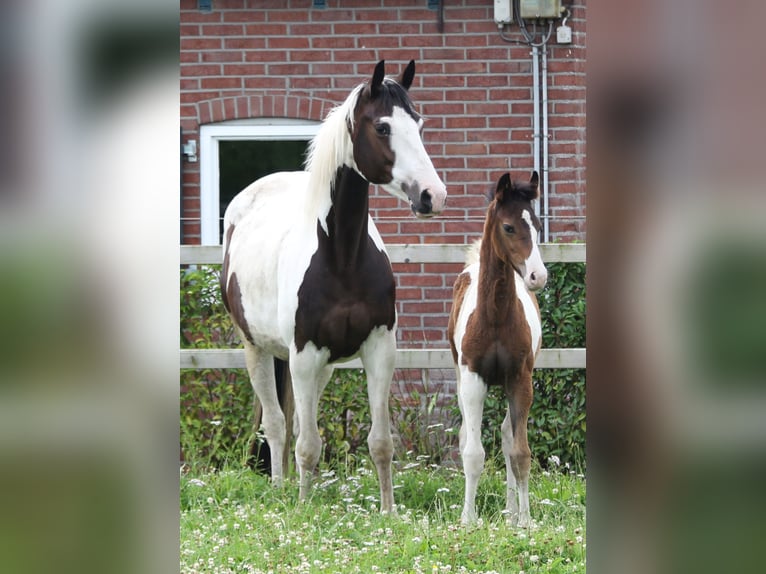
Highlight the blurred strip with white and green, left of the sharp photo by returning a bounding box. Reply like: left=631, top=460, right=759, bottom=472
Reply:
left=0, top=0, right=179, bottom=572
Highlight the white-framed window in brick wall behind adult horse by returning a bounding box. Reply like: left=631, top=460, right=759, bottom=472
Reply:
left=200, top=118, right=321, bottom=245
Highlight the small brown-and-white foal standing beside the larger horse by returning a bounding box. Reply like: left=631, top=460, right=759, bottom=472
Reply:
left=448, top=172, right=548, bottom=526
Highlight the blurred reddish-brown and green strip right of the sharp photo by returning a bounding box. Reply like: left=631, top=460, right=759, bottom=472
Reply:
left=587, top=0, right=766, bottom=573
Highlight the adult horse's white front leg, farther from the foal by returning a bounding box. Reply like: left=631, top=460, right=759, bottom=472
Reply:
left=290, top=342, right=333, bottom=500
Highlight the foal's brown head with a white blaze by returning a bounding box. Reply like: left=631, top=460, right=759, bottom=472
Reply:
left=484, top=171, right=548, bottom=291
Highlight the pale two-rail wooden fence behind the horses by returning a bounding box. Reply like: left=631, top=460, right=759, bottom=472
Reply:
left=180, top=243, right=585, bottom=369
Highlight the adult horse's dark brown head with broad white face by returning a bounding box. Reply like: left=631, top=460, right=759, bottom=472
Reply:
left=349, top=60, right=447, bottom=217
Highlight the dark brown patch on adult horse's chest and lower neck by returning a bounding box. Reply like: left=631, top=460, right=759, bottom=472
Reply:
left=295, top=166, right=396, bottom=362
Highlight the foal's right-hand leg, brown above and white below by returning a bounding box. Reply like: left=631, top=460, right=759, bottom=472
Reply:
left=502, top=375, right=532, bottom=528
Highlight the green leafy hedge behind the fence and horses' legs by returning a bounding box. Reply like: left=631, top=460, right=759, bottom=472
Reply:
left=180, top=263, right=586, bottom=470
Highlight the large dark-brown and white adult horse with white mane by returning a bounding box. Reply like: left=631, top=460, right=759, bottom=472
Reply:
left=221, top=61, right=447, bottom=512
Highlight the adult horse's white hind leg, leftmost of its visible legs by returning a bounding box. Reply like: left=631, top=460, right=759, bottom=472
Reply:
left=242, top=337, right=286, bottom=485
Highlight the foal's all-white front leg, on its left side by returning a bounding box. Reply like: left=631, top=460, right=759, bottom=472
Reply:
left=458, top=369, right=487, bottom=524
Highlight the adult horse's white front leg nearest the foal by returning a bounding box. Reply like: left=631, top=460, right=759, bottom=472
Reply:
left=359, top=327, right=396, bottom=512
